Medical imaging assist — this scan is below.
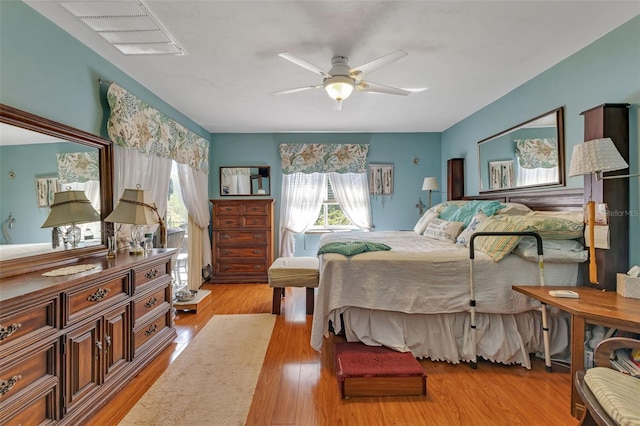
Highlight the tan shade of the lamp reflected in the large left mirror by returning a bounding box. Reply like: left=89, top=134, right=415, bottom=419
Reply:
left=41, top=190, right=100, bottom=228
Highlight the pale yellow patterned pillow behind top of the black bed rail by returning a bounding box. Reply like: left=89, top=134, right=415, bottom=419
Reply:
left=474, top=215, right=530, bottom=262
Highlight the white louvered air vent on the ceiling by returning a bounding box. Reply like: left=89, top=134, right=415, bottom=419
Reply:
left=60, top=0, right=185, bottom=55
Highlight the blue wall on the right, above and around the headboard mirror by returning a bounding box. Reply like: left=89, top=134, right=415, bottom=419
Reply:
left=442, top=16, right=640, bottom=265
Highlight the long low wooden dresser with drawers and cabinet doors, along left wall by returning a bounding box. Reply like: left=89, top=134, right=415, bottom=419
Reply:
left=0, top=249, right=176, bottom=425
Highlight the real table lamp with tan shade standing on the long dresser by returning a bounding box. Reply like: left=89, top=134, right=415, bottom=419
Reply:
left=105, top=185, right=167, bottom=255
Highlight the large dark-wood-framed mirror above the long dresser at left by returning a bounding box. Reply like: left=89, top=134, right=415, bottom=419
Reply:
left=0, top=104, right=113, bottom=277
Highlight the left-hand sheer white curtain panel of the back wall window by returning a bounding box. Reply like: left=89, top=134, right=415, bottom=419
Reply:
left=279, top=173, right=326, bottom=257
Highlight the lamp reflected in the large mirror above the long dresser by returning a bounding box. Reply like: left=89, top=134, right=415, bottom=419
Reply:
left=41, top=187, right=100, bottom=248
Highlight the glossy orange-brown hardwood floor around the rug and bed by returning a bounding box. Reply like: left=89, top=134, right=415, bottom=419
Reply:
left=90, top=284, right=578, bottom=426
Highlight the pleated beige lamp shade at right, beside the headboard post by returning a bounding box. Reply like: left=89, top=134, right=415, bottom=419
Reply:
left=569, top=138, right=629, bottom=176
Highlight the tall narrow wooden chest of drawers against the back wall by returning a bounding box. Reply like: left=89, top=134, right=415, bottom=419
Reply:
left=209, top=198, right=274, bottom=283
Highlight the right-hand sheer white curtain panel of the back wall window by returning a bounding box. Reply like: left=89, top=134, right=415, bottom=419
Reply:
left=329, top=173, right=372, bottom=230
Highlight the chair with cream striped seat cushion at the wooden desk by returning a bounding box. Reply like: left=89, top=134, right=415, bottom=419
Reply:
left=575, top=337, right=640, bottom=426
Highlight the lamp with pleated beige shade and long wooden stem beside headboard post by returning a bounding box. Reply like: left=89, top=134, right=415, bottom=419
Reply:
left=569, top=138, right=639, bottom=284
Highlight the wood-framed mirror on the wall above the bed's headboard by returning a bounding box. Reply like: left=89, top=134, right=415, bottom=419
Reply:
left=478, top=107, right=564, bottom=193
